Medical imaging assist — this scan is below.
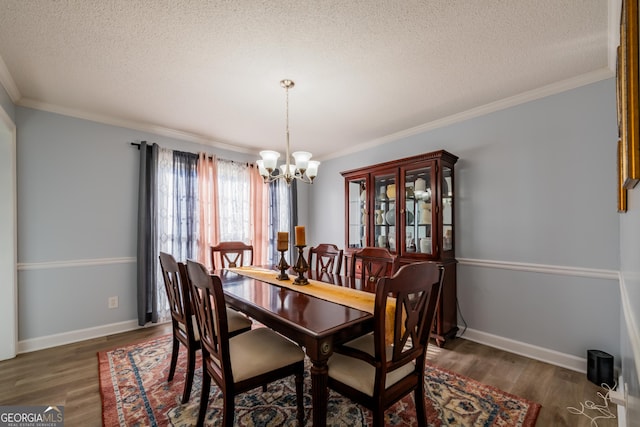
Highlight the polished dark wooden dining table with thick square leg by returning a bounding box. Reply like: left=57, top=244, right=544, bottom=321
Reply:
left=213, top=270, right=374, bottom=426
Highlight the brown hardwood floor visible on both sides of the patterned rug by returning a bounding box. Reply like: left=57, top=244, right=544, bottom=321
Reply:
left=0, top=325, right=617, bottom=427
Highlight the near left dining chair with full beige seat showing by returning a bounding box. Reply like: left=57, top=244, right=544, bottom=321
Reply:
left=187, top=260, right=304, bottom=426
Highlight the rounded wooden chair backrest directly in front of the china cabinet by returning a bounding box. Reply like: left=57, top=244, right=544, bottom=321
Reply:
left=349, top=247, right=398, bottom=290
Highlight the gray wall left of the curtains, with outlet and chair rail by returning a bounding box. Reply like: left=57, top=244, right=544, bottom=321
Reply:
left=16, top=107, right=253, bottom=349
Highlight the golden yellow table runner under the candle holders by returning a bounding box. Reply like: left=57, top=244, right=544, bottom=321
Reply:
left=226, top=266, right=396, bottom=342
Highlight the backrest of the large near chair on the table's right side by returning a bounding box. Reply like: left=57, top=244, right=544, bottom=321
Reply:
left=374, top=262, right=444, bottom=372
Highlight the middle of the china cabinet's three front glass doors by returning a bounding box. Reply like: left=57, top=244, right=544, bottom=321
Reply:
left=372, top=173, right=397, bottom=252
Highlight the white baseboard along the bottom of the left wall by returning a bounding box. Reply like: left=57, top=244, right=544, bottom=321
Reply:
left=18, top=320, right=149, bottom=353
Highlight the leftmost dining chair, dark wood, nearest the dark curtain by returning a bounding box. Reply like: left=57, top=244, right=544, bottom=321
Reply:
left=160, top=252, right=252, bottom=403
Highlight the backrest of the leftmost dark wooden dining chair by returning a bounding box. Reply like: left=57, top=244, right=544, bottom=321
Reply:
left=159, top=252, right=194, bottom=338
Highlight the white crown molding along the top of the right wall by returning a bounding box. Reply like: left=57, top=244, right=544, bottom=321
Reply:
left=320, top=67, right=615, bottom=160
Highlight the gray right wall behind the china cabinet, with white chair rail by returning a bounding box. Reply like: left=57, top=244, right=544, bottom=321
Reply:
left=309, top=79, right=620, bottom=368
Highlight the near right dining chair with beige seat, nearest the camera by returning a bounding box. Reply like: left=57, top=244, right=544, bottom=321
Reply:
left=328, top=262, right=444, bottom=427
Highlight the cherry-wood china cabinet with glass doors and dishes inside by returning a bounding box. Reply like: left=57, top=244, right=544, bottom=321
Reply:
left=342, top=150, right=458, bottom=346
